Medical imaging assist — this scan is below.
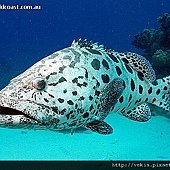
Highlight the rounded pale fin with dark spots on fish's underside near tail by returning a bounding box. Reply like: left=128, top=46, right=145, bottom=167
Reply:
left=123, top=103, right=151, bottom=122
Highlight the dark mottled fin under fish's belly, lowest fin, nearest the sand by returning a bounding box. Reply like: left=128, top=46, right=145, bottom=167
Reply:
left=85, top=120, right=113, bottom=135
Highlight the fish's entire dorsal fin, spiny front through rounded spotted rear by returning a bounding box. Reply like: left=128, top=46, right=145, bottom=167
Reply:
left=71, top=39, right=156, bottom=82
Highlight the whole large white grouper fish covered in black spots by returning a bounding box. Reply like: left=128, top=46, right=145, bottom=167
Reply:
left=0, top=39, right=170, bottom=135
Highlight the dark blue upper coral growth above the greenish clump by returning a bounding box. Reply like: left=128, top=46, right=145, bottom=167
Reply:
left=132, top=13, right=170, bottom=55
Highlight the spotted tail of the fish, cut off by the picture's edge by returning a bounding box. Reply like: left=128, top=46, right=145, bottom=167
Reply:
left=151, top=76, right=170, bottom=112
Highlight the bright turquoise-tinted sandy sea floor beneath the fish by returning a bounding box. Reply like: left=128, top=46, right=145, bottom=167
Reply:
left=0, top=114, right=170, bottom=160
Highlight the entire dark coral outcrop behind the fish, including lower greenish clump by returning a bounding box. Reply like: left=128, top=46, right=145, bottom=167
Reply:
left=132, top=13, right=170, bottom=75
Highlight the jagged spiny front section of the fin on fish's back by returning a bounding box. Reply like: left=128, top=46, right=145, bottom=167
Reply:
left=71, top=39, right=114, bottom=53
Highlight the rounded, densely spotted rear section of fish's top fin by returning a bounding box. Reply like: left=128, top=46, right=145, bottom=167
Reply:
left=120, top=52, right=156, bottom=82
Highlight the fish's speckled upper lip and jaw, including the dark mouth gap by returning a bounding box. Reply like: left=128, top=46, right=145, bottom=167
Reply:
left=0, top=93, right=63, bottom=126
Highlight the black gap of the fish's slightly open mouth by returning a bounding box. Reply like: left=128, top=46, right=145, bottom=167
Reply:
left=0, top=106, right=37, bottom=121
